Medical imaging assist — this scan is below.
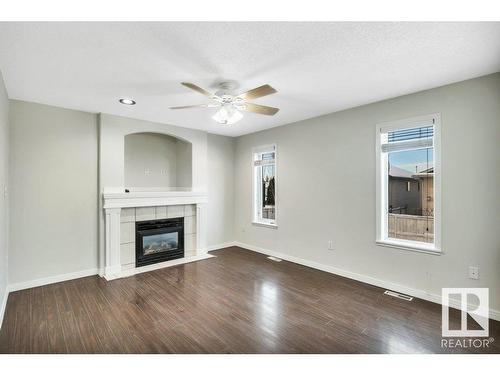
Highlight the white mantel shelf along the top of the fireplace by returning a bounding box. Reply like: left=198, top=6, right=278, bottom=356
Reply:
left=102, top=191, right=207, bottom=209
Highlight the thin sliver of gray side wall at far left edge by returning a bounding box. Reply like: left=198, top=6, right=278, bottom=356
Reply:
left=0, top=72, right=9, bottom=318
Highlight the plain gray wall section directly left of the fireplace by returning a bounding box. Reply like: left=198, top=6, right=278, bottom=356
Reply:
left=9, top=100, right=97, bottom=283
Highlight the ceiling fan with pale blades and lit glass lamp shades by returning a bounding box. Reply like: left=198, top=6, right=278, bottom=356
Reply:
left=170, top=82, right=279, bottom=125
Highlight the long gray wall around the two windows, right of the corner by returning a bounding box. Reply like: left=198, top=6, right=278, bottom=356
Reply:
left=234, top=73, right=500, bottom=310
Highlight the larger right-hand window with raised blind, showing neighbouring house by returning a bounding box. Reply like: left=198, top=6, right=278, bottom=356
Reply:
left=377, top=115, right=441, bottom=252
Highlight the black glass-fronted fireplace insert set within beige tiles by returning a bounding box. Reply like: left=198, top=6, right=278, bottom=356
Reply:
left=135, top=217, right=184, bottom=267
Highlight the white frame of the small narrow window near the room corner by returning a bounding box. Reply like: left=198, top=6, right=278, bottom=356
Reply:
left=252, top=144, right=278, bottom=229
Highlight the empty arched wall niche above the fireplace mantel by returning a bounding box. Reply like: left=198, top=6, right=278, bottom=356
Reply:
left=123, top=132, right=193, bottom=191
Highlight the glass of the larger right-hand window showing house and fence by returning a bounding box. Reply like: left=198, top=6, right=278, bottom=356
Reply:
left=387, top=147, right=434, bottom=243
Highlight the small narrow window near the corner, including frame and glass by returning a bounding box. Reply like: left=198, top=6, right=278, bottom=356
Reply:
left=253, top=145, right=276, bottom=226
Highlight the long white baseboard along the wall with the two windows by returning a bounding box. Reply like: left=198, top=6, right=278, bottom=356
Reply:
left=233, top=241, right=500, bottom=321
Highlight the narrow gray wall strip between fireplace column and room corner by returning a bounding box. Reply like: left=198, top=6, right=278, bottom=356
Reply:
left=207, top=134, right=235, bottom=246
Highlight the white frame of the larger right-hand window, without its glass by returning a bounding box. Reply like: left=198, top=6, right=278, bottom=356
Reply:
left=375, top=113, right=442, bottom=255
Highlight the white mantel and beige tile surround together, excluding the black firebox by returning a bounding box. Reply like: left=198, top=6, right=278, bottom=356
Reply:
left=103, top=191, right=212, bottom=280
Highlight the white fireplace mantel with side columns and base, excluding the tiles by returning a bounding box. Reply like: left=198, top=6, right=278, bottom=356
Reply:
left=102, top=188, right=209, bottom=280
